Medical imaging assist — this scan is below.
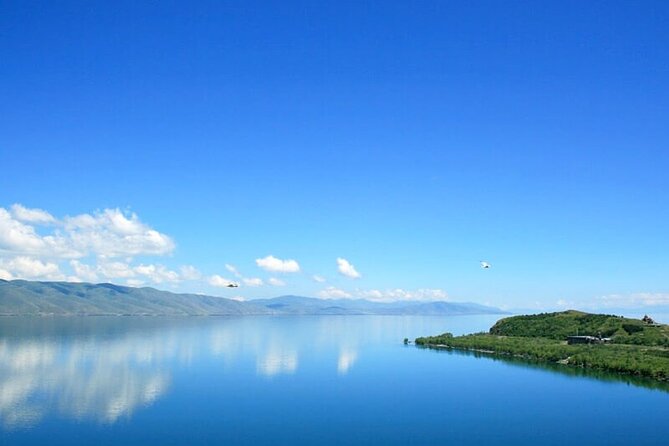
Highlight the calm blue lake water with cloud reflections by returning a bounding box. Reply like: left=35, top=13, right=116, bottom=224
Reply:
left=0, top=316, right=669, bottom=446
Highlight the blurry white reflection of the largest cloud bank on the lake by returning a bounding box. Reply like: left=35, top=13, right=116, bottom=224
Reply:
left=0, top=336, right=170, bottom=428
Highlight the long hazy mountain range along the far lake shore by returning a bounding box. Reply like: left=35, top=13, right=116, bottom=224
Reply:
left=0, top=280, right=504, bottom=316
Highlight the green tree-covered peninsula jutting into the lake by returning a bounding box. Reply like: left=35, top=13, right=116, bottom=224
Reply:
left=415, top=311, right=669, bottom=381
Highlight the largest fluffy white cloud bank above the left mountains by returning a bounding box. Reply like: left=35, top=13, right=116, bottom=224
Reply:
left=0, top=204, right=201, bottom=283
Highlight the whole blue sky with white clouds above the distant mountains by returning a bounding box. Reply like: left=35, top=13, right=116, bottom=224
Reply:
left=0, top=1, right=669, bottom=308
